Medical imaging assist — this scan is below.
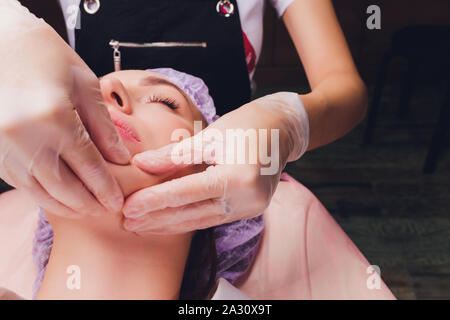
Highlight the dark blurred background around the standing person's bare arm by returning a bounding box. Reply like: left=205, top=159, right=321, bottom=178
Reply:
left=0, top=0, right=450, bottom=299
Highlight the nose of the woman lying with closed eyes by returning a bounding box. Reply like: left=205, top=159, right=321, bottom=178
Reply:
left=100, top=78, right=133, bottom=114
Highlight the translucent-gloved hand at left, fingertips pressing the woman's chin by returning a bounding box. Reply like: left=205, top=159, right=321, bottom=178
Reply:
left=0, top=0, right=130, bottom=217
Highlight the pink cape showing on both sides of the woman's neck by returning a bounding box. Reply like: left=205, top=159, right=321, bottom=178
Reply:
left=0, top=174, right=395, bottom=300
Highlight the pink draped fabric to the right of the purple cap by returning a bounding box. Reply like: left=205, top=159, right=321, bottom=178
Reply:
left=238, top=174, right=395, bottom=300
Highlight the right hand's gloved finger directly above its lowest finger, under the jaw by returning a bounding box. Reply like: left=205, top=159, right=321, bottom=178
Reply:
left=123, top=166, right=226, bottom=218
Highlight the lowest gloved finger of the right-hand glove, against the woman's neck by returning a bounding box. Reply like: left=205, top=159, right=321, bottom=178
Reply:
left=124, top=199, right=227, bottom=231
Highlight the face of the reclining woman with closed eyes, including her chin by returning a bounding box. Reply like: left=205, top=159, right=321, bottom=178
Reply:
left=100, top=70, right=203, bottom=196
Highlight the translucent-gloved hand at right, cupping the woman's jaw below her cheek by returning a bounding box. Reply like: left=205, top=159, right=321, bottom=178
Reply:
left=123, top=92, right=309, bottom=234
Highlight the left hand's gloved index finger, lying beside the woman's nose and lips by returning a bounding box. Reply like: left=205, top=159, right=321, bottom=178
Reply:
left=71, top=67, right=130, bottom=164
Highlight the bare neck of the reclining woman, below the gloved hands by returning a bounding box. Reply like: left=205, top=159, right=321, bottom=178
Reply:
left=37, top=214, right=192, bottom=300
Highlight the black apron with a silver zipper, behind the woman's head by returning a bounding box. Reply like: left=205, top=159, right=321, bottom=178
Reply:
left=75, top=0, right=251, bottom=115
